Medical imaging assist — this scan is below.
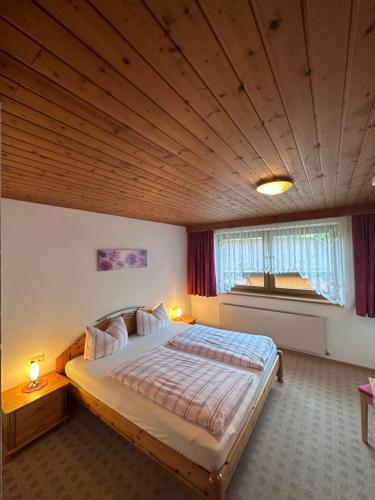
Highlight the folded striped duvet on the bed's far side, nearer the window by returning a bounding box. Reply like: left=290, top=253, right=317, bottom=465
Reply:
left=168, top=325, right=276, bottom=370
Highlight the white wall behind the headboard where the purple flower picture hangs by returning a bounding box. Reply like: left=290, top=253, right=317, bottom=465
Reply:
left=1, top=200, right=190, bottom=389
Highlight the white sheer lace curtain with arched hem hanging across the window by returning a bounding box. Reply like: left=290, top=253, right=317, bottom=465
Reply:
left=215, top=217, right=353, bottom=307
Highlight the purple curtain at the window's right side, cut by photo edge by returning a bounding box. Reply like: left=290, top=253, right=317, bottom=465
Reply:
left=352, top=214, right=375, bottom=318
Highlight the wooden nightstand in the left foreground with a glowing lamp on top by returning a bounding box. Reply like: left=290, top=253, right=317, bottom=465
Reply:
left=2, top=372, right=69, bottom=458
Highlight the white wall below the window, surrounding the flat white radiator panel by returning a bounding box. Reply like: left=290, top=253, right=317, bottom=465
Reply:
left=191, top=294, right=375, bottom=368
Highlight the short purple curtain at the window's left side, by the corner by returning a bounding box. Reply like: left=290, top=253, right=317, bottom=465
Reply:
left=187, top=231, right=216, bottom=297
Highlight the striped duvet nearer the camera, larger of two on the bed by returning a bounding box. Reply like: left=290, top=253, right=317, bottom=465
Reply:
left=108, top=347, right=253, bottom=435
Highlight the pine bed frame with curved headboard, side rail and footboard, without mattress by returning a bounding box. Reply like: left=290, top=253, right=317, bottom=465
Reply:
left=56, top=308, right=283, bottom=500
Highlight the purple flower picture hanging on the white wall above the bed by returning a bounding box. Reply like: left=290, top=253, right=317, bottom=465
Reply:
left=98, top=250, right=147, bottom=271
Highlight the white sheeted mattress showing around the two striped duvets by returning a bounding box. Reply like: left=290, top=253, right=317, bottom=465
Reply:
left=65, top=323, right=276, bottom=471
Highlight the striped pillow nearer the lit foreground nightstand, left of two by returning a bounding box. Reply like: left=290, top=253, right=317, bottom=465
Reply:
left=83, top=316, right=128, bottom=360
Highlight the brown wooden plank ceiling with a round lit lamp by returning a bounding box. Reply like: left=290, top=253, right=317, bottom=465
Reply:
left=0, top=0, right=375, bottom=225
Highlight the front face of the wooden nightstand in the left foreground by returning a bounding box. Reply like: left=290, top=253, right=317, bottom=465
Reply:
left=15, top=389, right=64, bottom=447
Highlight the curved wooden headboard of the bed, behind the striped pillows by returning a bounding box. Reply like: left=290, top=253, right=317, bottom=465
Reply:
left=56, top=307, right=143, bottom=374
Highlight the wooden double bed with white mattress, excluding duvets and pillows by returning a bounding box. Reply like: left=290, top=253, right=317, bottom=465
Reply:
left=56, top=308, right=283, bottom=500
